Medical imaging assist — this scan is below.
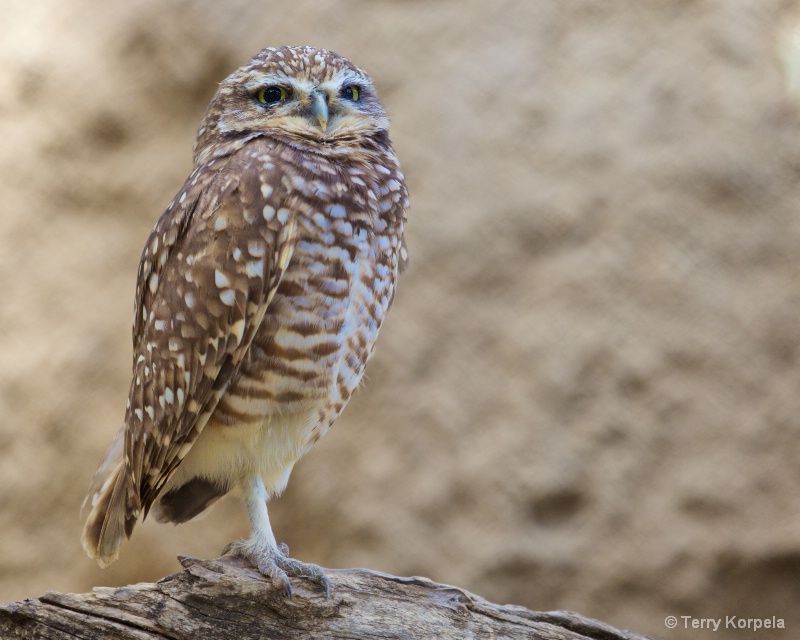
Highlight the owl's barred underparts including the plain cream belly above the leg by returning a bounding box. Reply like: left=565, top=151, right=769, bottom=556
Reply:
left=195, top=208, right=396, bottom=492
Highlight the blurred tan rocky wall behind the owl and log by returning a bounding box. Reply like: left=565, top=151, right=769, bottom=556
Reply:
left=0, top=0, right=800, bottom=640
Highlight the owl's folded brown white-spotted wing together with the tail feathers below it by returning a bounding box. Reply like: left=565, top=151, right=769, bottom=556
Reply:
left=83, top=142, right=296, bottom=564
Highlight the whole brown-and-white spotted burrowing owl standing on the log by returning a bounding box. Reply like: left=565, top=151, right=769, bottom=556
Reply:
left=82, top=47, right=408, bottom=592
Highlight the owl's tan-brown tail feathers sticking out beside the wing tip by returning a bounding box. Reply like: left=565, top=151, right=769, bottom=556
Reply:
left=81, top=431, right=136, bottom=567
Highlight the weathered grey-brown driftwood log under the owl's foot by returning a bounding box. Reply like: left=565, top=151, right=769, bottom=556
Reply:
left=0, top=557, right=644, bottom=640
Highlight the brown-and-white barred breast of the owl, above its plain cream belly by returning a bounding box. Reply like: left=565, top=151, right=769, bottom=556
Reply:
left=220, top=202, right=397, bottom=431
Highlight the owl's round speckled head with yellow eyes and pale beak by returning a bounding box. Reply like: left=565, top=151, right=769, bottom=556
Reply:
left=195, top=47, right=389, bottom=161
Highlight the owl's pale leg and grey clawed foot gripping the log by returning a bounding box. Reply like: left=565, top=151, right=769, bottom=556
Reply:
left=223, top=476, right=331, bottom=598
